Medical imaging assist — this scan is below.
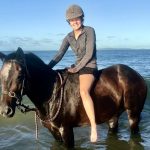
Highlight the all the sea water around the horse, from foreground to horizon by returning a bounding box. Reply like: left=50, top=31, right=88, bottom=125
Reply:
left=0, top=50, right=150, bottom=150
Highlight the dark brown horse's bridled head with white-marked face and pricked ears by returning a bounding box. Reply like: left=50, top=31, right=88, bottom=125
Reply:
left=0, top=48, right=25, bottom=117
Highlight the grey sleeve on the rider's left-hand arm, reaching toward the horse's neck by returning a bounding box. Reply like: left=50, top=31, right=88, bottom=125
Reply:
left=49, top=36, right=70, bottom=68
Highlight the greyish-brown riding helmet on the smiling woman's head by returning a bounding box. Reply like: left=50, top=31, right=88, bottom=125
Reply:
left=66, top=5, right=84, bottom=20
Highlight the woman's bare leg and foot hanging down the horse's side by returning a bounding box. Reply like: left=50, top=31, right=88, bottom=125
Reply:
left=79, top=74, right=97, bottom=142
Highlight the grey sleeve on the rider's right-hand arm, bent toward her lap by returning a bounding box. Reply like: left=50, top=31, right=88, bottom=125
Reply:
left=74, top=28, right=96, bottom=72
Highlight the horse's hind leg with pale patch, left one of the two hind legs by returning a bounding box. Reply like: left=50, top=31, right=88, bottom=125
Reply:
left=108, top=115, right=118, bottom=132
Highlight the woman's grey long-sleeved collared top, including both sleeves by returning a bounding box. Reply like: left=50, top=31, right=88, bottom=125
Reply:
left=49, top=26, right=97, bottom=72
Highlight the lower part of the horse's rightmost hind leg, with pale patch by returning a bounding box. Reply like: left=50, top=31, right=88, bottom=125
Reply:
left=127, top=109, right=140, bottom=134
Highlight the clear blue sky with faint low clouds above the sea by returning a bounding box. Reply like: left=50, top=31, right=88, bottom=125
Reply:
left=0, top=0, right=150, bottom=51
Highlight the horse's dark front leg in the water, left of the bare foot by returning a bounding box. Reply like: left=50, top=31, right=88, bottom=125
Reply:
left=61, top=126, right=74, bottom=148
